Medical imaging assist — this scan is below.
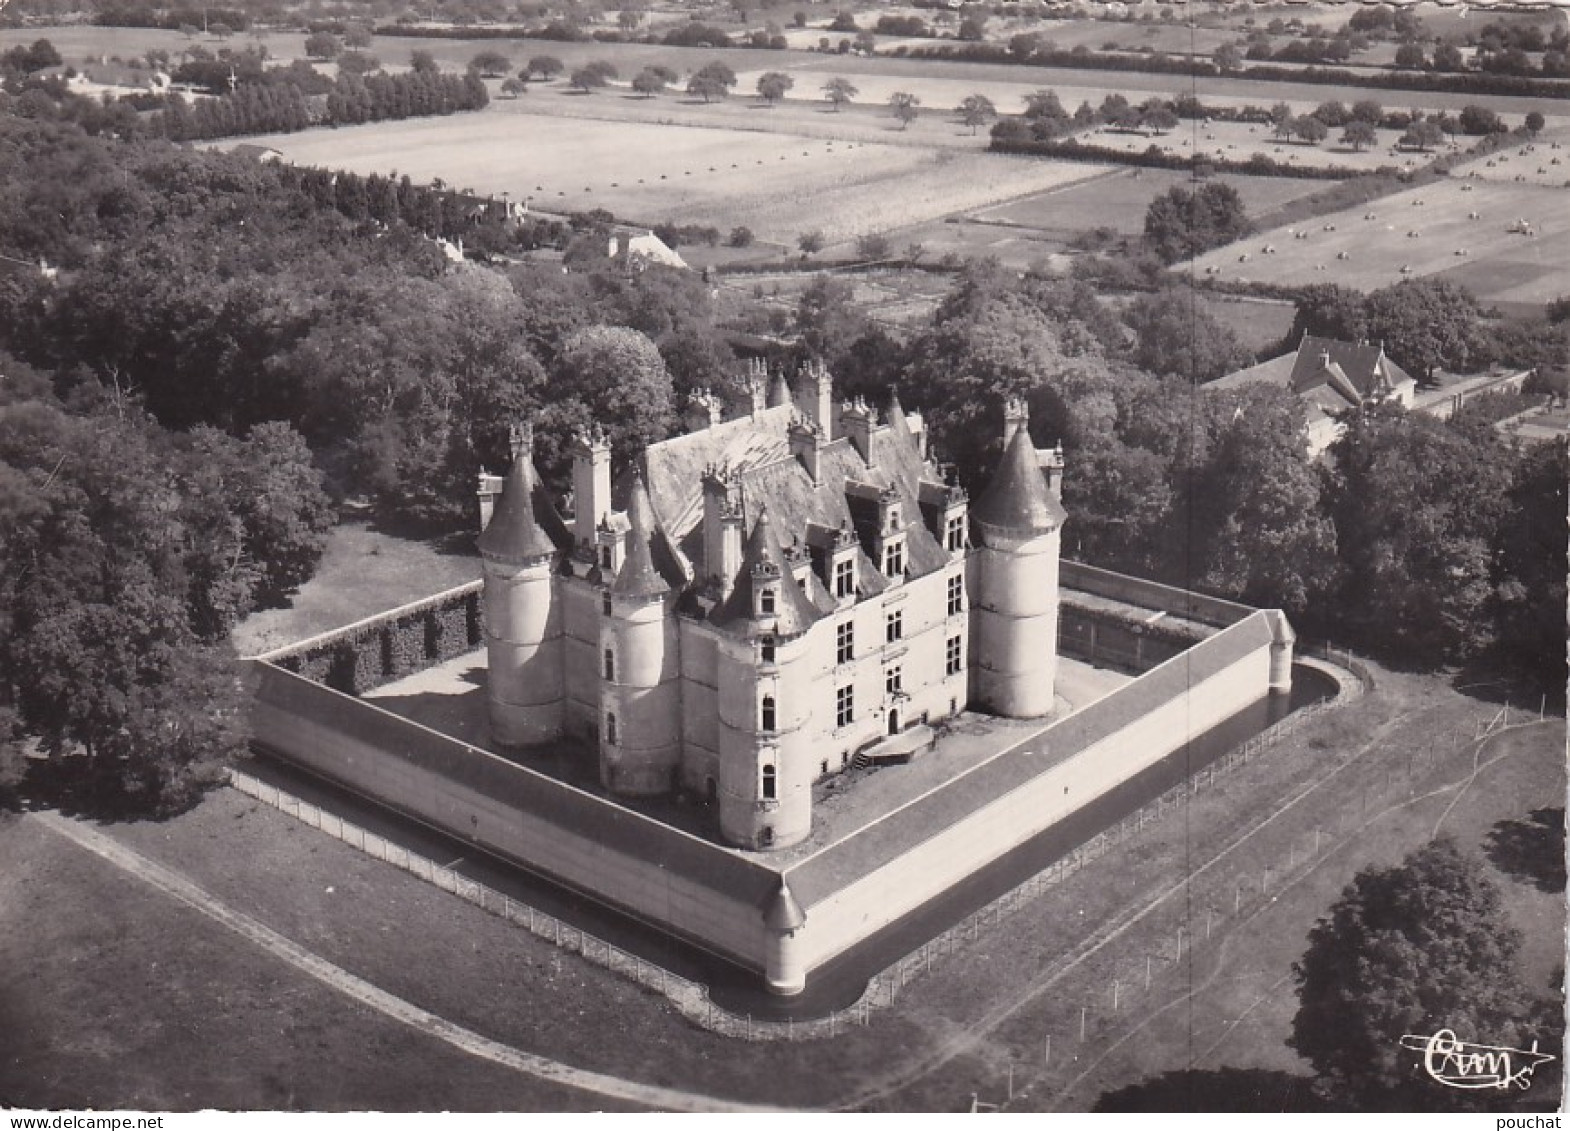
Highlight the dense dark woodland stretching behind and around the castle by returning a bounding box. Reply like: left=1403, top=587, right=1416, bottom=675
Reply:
left=0, top=115, right=1570, bottom=809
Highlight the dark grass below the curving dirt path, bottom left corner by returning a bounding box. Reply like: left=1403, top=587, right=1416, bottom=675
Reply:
left=0, top=810, right=604, bottom=1111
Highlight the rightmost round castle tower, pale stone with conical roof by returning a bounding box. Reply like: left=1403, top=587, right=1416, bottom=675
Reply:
left=967, top=402, right=1064, bottom=718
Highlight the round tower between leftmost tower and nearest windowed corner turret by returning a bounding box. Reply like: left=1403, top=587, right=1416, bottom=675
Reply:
left=600, top=479, right=681, bottom=796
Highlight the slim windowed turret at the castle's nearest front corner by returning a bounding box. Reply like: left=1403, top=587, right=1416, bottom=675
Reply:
left=711, top=507, right=821, bottom=848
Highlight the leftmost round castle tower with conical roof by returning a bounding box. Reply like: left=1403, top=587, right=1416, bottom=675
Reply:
left=479, top=427, right=570, bottom=746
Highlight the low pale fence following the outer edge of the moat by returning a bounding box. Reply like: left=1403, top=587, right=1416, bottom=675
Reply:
left=231, top=649, right=1372, bottom=1041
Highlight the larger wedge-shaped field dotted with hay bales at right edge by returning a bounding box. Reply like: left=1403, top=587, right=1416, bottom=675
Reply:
left=1193, top=178, right=1570, bottom=303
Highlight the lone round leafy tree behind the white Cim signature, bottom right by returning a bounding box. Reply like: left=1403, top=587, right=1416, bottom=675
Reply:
left=1291, top=837, right=1534, bottom=1111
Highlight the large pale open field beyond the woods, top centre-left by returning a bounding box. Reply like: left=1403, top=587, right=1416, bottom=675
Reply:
left=232, top=109, right=1099, bottom=243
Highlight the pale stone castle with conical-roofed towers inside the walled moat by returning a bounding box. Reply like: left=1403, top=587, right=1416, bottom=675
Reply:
left=479, top=363, right=1064, bottom=850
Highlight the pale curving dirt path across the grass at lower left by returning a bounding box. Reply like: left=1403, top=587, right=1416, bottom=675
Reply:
left=28, top=812, right=777, bottom=1112
